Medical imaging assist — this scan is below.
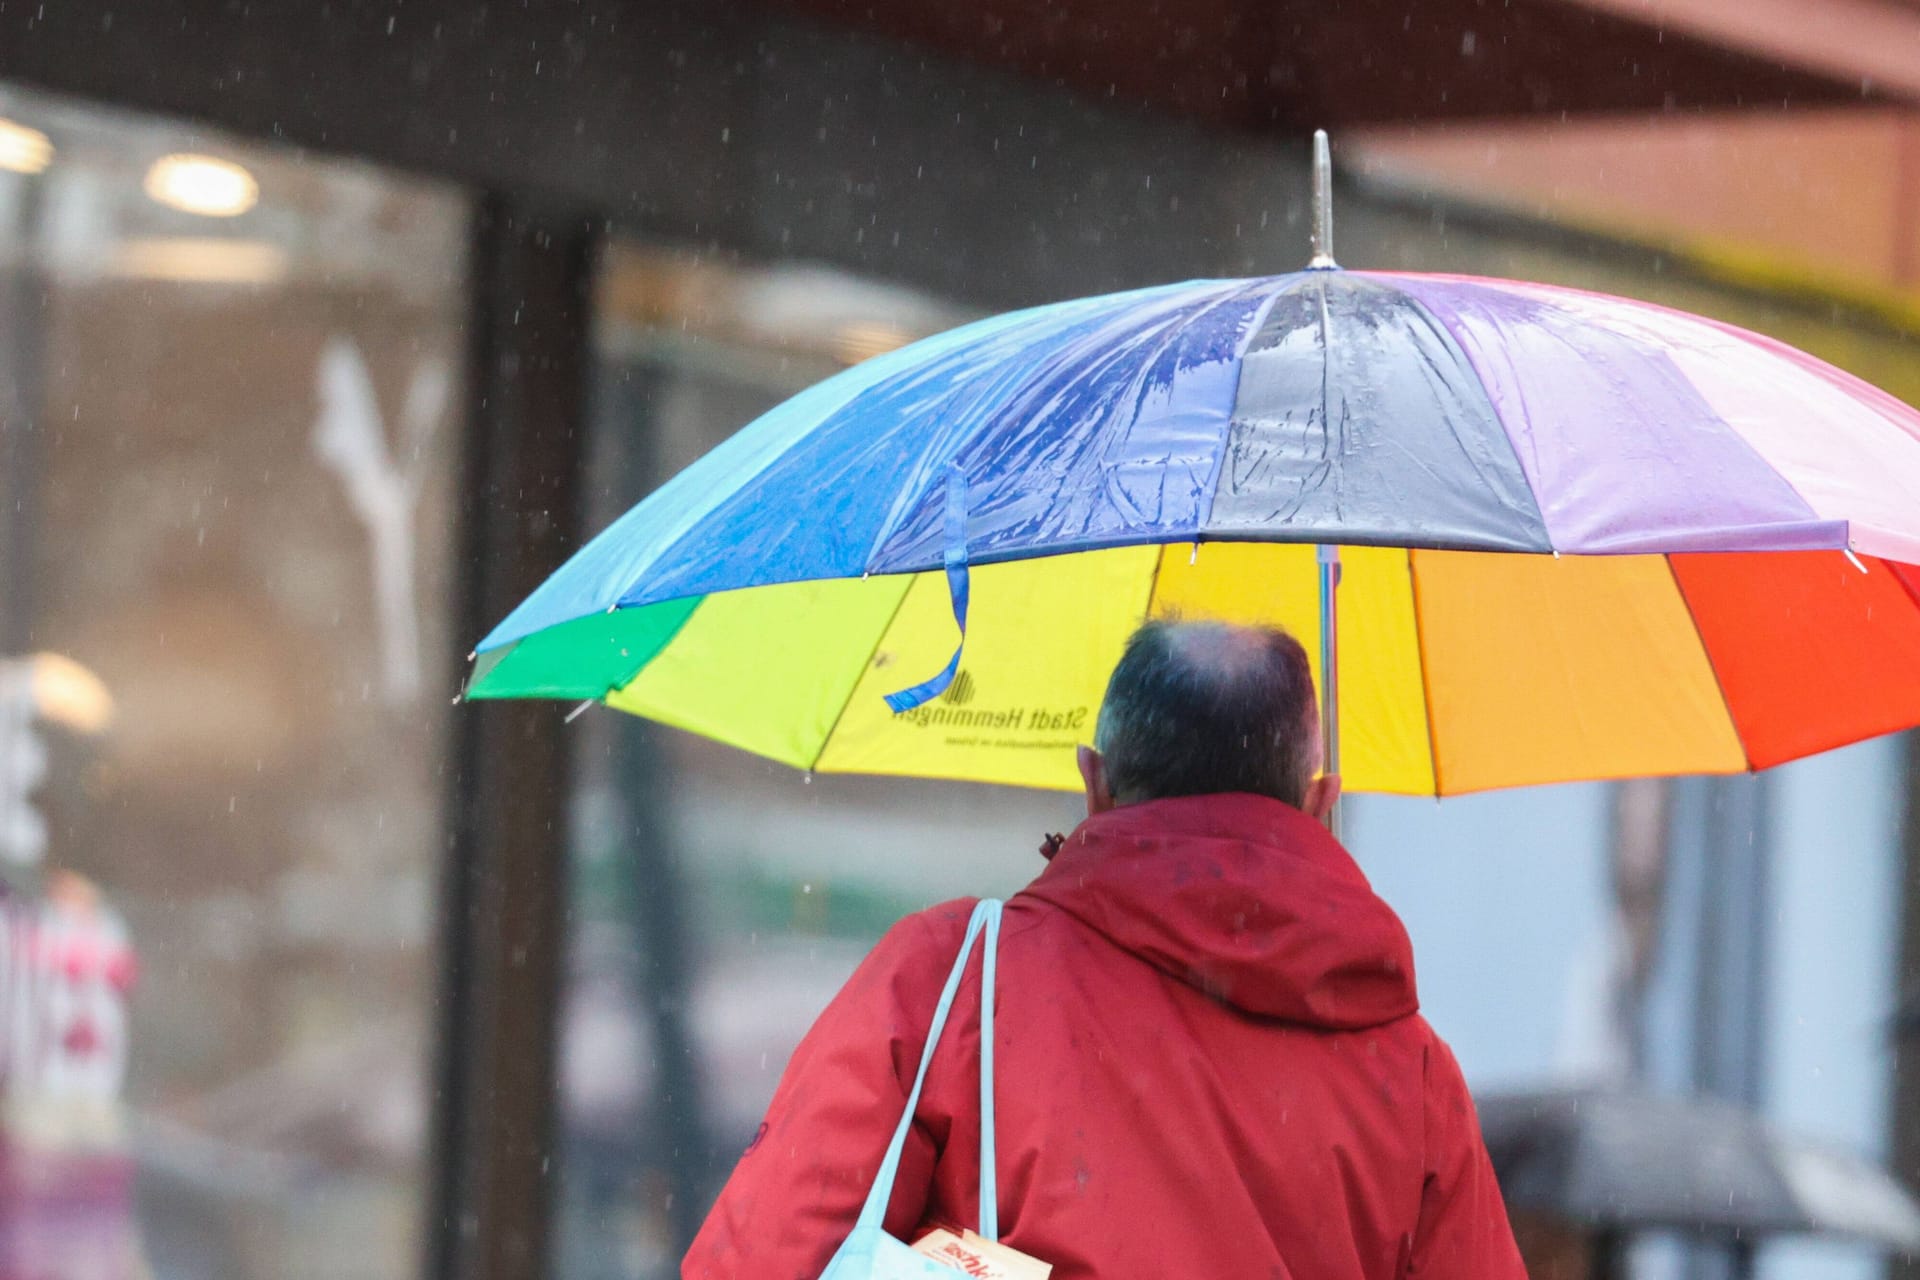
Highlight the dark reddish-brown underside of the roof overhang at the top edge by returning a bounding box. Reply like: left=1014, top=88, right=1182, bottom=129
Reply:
left=762, top=0, right=1920, bottom=132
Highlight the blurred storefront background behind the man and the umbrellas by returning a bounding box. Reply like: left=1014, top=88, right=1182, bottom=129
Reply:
left=0, top=0, right=1920, bottom=1280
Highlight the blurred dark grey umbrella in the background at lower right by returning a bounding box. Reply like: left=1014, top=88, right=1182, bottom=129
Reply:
left=1476, top=1090, right=1920, bottom=1253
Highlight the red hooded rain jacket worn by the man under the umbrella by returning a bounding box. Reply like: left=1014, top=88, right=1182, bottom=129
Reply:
left=682, top=794, right=1526, bottom=1280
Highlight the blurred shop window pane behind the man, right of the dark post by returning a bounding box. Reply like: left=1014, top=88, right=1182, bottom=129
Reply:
left=555, top=246, right=1075, bottom=1280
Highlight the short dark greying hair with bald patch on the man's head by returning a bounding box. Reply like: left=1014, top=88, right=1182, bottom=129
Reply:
left=1094, top=620, right=1319, bottom=808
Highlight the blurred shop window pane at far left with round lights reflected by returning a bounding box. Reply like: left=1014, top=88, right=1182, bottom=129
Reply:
left=0, top=86, right=465, bottom=1280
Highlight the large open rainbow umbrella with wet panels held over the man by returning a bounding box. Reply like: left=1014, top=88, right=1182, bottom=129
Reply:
left=468, top=138, right=1920, bottom=794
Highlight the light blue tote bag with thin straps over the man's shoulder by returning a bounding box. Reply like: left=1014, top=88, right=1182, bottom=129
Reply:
left=820, top=898, right=1000, bottom=1280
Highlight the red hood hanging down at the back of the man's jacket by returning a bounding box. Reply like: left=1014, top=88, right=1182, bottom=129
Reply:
left=1025, top=793, right=1419, bottom=1031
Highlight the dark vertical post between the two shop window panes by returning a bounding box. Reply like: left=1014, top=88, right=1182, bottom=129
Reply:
left=424, top=196, right=599, bottom=1280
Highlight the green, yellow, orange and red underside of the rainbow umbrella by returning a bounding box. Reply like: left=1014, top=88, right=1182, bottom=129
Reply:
left=468, top=543, right=1920, bottom=794
